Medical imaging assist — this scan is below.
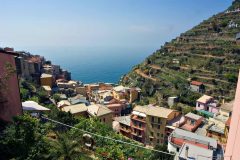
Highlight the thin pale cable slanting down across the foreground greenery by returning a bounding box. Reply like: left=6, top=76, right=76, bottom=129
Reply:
left=41, top=116, right=175, bottom=156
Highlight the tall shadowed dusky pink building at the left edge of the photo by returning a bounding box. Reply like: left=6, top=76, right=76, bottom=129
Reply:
left=0, top=51, right=22, bottom=121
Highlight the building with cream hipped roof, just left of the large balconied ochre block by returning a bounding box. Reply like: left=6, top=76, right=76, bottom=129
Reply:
left=87, top=104, right=113, bottom=127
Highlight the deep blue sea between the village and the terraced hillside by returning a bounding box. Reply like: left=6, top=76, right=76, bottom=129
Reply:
left=31, top=47, right=154, bottom=83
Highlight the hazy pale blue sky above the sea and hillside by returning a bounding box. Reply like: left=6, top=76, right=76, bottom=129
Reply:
left=0, top=0, right=232, bottom=49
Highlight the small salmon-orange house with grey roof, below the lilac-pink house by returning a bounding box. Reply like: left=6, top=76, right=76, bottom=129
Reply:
left=181, top=112, right=203, bottom=132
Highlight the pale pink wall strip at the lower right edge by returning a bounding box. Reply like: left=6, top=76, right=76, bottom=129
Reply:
left=224, top=70, right=240, bottom=160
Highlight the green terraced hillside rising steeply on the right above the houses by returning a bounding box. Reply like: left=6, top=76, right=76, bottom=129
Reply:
left=121, top=0, right=240, bottom=105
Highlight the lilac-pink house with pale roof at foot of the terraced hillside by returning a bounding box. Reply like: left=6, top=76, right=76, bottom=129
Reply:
left=196, top=95, right=220, bottom=113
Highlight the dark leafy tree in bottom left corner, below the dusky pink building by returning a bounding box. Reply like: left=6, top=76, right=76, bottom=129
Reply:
left=0, top=114, right=49, bottom=160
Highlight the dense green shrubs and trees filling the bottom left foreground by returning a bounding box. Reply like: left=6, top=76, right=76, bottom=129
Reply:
left=0, top=110, right=172, bottom=160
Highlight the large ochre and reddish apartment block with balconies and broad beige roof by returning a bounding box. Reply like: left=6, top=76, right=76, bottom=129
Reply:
left=131, top=105, right=180, bottom=146
